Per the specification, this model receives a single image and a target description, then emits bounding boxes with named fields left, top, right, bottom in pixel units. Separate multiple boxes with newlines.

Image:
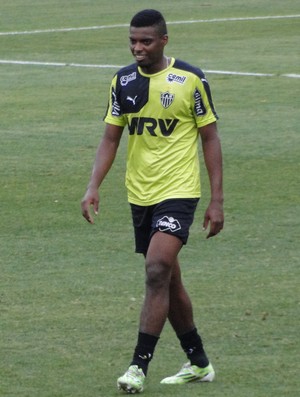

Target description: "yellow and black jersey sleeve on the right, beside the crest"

left=192, top=76, right=218, bottom=128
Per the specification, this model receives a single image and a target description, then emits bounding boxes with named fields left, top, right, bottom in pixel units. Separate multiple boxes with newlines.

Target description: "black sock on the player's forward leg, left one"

left=130, top=332, right=159, bottom=375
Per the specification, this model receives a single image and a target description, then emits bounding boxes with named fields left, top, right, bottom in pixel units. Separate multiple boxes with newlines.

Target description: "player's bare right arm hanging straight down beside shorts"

left=199, top=123, right=224, bottom=238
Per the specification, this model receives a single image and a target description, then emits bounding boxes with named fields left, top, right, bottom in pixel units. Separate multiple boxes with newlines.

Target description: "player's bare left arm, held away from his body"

left=81, top=124, right=123, bottom=223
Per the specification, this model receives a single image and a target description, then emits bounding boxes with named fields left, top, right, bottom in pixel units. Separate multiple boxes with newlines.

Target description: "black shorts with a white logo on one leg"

left=130, top=198, right=199, bottom=254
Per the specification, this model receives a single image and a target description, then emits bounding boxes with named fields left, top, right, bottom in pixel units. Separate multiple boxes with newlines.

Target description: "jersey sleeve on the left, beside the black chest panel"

left=103, top=74, right=127, bottom=127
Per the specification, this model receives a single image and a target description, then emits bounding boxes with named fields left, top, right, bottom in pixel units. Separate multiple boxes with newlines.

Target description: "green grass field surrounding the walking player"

left=0, top=0, right=300, bottom=397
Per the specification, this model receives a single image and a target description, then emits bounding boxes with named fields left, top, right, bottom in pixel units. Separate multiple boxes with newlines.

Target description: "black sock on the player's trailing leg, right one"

left=178, top=328, right=209, bottom=368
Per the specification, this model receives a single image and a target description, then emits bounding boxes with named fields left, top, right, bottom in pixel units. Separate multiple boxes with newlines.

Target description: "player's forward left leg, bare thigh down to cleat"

left=117, top=232, right=182, bottom=393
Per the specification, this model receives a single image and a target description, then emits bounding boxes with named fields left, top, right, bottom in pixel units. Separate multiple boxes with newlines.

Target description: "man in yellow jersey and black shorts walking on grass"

left=82, top=10, right=224, bottom=393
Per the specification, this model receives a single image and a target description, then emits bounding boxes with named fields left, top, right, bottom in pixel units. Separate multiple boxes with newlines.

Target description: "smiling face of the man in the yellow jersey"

left=129, top=26, right=168, bottom=74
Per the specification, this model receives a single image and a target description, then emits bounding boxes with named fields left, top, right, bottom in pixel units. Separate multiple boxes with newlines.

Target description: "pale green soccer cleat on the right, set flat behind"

left=160, top=362, right=215, bottom=385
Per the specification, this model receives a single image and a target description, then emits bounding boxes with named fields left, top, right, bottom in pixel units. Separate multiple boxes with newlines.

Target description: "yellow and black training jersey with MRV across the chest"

left=104, top=59, right=217, bottom=206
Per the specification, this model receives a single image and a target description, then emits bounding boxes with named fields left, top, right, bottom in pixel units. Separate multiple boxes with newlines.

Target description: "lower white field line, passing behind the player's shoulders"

left=0, top=59, right=300, bottom=79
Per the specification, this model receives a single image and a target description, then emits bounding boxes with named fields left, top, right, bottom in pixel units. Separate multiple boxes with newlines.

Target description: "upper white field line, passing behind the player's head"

left=0, top=14, right=300, bottom=36
